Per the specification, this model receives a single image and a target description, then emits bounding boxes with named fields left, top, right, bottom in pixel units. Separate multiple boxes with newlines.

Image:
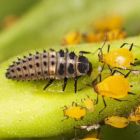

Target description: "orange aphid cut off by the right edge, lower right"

left=128, top=106, right=140, bottom=123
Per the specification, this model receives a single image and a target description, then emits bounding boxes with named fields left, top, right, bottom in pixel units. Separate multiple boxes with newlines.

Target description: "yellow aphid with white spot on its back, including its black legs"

left=98, top=43, right=135, bottom=70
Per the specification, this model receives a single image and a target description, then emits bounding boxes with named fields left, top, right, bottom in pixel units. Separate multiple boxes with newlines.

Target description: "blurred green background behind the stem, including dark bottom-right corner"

left=0, top=0, right=140, bottom=140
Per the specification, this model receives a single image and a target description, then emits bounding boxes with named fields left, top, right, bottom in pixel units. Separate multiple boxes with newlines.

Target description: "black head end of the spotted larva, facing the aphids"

left=77, top=56, right=92, bottom=75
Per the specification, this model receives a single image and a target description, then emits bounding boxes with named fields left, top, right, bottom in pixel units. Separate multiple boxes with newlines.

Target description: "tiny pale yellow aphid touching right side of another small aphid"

left=82, top=97, right=94, bottom=112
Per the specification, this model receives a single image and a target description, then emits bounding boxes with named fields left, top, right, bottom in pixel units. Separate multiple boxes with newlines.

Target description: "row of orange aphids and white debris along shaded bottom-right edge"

left=75, top=106, right=140, bottom=140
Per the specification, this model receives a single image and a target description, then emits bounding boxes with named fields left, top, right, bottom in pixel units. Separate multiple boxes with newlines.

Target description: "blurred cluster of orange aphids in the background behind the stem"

left=62, top=16, right=126, bottom=45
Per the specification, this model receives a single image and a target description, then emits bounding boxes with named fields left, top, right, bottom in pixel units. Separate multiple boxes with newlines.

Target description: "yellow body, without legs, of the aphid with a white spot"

left=100, top=48, right=134, bottom=69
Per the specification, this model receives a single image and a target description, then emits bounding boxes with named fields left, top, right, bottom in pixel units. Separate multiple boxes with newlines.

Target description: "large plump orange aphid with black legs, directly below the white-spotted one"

left=93, top=70, right=135, bottom=112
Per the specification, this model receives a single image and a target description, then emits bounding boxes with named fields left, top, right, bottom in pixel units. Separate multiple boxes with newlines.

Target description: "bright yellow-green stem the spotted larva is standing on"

left=0, top=37, right=140, bottom=139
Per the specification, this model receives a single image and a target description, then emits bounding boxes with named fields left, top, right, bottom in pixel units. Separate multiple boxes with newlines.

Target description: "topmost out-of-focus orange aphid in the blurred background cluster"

left=94, top=16, right=123, bottom=31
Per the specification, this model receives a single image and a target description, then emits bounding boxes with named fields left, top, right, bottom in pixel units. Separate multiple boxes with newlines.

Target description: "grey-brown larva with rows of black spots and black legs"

left=6, top=49, right=92, bottom=92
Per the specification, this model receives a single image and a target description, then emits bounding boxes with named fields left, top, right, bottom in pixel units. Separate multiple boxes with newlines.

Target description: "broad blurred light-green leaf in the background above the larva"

left=0, top=0, right=140, bottom=61
